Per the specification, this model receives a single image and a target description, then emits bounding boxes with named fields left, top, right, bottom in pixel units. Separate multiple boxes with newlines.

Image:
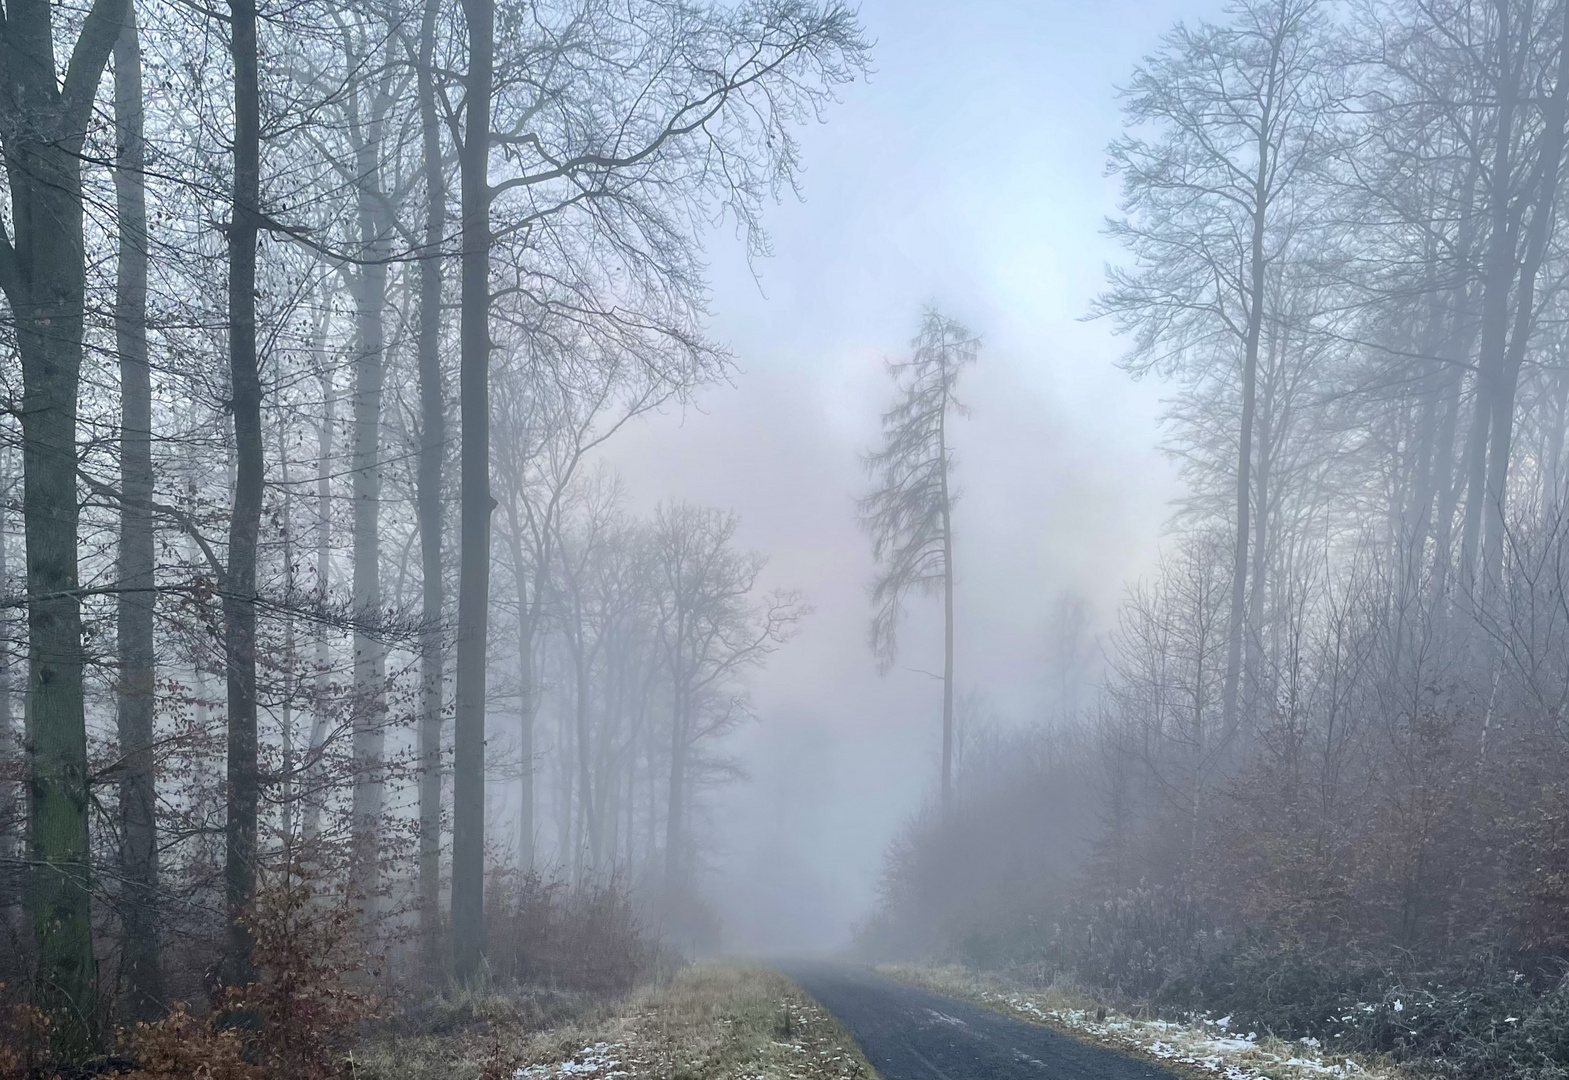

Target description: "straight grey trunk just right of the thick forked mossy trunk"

left=115, top=3, right=163, bottom=1020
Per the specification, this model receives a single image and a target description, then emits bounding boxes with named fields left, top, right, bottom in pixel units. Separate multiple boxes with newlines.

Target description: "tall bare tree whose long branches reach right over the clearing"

left=453, top=0, right=866, bottom=978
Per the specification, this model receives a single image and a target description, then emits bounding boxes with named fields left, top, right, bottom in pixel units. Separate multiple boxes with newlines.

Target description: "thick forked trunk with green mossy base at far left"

left=0, top=0, right=126, bottom=1060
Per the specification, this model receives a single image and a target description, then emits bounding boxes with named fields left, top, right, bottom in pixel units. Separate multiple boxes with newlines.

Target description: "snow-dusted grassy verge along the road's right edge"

left=877, top=964, right=1412, bottom=1080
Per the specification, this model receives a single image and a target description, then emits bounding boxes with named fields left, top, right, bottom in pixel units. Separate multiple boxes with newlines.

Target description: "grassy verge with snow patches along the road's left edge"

left=355, top=962, right=877, bottom=1080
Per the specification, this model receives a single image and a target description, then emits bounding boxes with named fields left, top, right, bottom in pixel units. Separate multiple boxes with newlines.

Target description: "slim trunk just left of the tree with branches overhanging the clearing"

left=416, top=0, right=447, bottom=975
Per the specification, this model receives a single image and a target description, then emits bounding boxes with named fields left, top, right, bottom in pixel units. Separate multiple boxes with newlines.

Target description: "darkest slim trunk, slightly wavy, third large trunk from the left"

left=223, top=0, right=262, bottom=986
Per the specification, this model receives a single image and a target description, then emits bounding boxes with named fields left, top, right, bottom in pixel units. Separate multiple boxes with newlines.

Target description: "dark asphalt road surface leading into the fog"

left=781, top=964, right=1178, bottom=1080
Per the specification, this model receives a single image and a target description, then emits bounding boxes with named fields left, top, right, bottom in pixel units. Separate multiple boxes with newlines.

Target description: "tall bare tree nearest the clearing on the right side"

left=1098, top=0, right=1331, bottom=756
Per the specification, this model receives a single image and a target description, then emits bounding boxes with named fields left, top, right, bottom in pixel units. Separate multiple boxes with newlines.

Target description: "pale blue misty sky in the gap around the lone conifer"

left=609, top=0, right=1219, bottom=950
